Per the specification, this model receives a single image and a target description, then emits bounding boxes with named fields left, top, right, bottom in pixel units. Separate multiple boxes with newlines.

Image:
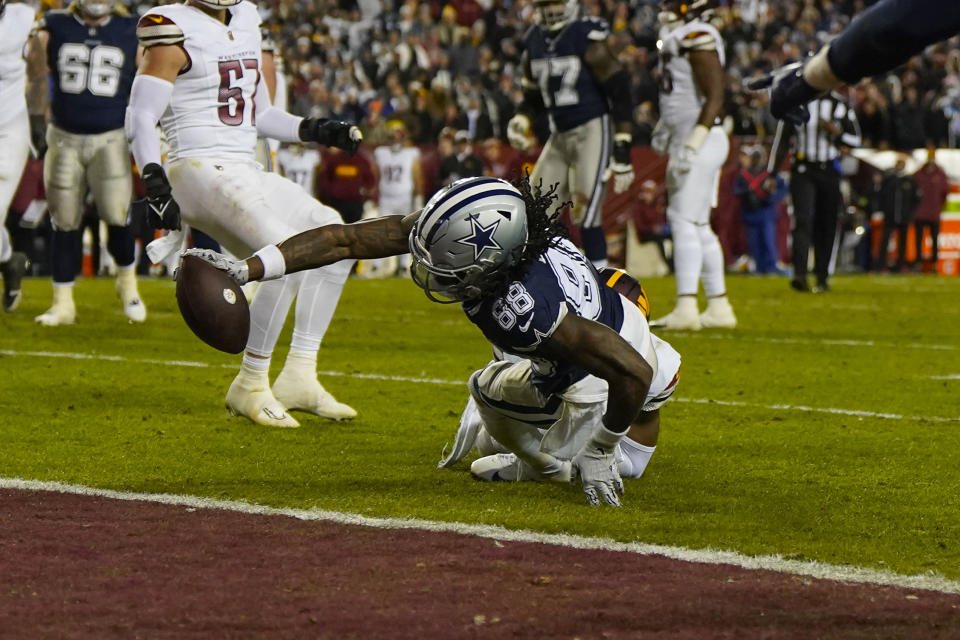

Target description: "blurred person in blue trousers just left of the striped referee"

left=733, top=146, right=787, bottom=275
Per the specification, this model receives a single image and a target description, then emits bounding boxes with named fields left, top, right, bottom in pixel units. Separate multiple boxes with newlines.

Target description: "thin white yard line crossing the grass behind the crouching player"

left=0, top=349, right=960, bottom=422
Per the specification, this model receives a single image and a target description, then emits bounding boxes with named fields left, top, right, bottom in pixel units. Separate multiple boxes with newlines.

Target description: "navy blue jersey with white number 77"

left=524, top=18, right=610, bottom=131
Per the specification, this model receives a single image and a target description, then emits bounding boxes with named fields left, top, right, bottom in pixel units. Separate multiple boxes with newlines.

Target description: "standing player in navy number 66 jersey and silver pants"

left=29, top=0, right=147, bottom=326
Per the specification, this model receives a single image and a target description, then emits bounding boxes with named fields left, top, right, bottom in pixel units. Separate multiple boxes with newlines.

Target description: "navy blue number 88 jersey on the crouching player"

left=464, top=240, right=623, bottom=395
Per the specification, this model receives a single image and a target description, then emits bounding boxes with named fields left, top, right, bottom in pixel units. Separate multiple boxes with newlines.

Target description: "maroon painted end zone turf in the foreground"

left=0, top=490, right=960, bottom=640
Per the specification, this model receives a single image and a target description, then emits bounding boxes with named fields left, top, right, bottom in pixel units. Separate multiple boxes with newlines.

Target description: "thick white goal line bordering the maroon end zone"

left=0, top=478, right=960, bottom=594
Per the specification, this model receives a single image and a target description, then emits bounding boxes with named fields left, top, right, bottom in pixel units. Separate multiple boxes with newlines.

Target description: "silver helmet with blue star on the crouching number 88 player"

left=410, top=177, right=527, bottom=303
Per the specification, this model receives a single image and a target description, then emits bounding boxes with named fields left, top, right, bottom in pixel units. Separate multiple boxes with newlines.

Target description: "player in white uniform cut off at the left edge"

left=0, top=0, right=34, bottom=311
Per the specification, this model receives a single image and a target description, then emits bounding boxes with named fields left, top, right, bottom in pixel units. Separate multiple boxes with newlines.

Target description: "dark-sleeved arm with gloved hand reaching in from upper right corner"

left=747, top=0, right=960, bottom=124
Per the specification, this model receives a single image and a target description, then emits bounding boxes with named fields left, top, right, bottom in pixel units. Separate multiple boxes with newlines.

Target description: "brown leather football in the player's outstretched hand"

left=177, top=256, right=250, bottom=353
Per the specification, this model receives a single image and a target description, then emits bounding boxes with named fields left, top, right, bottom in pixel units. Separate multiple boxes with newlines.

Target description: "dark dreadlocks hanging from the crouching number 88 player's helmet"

left=472, top=172, right=572, bottom=297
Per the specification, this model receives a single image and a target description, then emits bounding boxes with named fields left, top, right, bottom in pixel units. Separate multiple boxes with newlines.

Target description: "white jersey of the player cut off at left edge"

left=0, top=4, right=34, bottom=125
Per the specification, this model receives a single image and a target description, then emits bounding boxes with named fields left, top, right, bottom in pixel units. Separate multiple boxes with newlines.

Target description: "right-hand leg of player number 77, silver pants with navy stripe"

left=570, top=115, right=612, bottom=269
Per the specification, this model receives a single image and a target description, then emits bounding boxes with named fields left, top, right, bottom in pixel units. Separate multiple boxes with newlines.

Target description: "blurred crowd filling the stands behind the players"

left=11, top=0, right=960, bottom=276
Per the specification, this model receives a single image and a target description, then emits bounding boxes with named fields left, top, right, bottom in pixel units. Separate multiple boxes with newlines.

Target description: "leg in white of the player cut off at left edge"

left=0, top=112, right=30, bottom=311
